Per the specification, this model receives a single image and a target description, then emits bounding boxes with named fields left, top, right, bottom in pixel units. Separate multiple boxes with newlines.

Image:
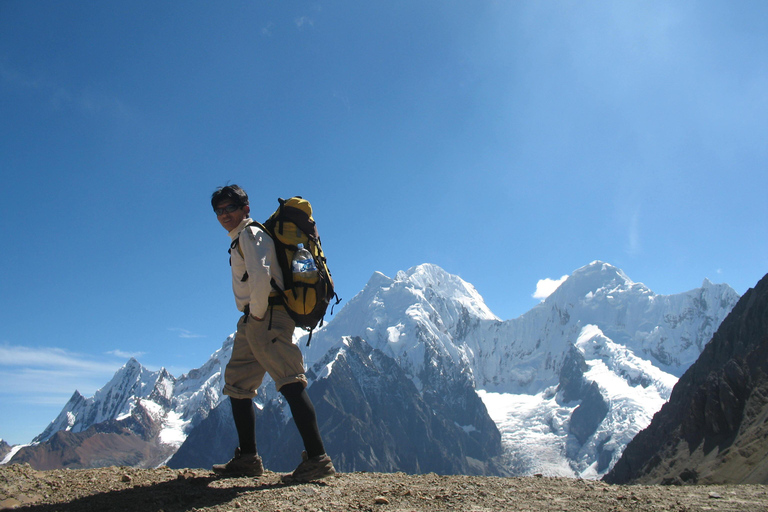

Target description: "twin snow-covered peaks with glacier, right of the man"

left=292, top=261, right=738, bottom=478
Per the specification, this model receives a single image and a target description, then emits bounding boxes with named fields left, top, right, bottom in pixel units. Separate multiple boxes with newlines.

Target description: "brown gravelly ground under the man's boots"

left=0, top=464, right=768, bottom=512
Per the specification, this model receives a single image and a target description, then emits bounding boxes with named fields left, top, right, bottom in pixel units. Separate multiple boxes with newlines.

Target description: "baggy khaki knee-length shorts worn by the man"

left=223, top=307, right=307, bottom=398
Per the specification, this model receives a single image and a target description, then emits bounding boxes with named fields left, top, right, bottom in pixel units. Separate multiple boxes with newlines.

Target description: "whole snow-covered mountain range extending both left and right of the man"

left=7, top=261, right=738, bottom=478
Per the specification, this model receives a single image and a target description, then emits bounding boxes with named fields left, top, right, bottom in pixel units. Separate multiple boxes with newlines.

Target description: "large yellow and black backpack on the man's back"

left=237, top=196, right=341, bottom=346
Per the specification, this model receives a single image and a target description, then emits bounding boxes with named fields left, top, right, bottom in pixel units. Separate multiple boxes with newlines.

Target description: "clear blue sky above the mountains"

left=0, top=0, right=768, bottom=443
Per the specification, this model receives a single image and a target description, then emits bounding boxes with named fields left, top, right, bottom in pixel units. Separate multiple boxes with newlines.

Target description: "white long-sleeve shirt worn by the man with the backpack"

left=229, top=218, right=283, bottom=318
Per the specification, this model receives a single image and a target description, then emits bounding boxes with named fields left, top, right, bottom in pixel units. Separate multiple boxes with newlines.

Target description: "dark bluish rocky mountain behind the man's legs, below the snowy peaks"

left=168, top=338, right=501, bottom=474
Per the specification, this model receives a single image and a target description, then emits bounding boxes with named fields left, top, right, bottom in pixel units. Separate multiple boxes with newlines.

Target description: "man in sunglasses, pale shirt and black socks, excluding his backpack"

left=211, top=185, right=336, bottom=482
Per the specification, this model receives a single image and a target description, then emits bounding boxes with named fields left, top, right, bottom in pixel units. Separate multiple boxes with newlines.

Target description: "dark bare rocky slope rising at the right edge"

left=604, top=275, right=768, bottom=484
